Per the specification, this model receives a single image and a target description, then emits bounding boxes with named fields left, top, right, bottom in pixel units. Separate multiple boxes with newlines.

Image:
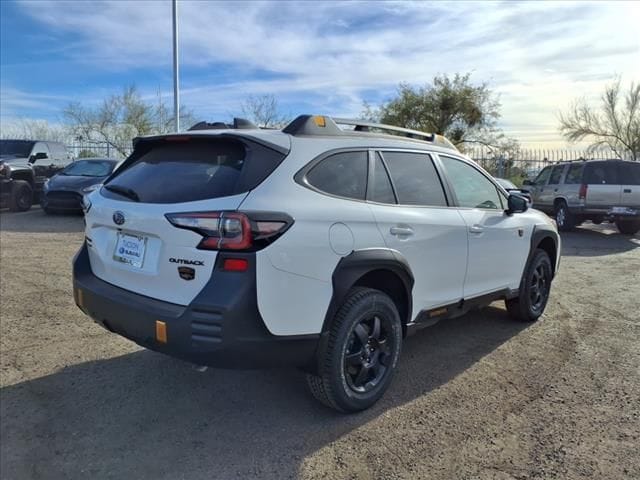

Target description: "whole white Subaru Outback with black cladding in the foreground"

left=73, top=115, right=560, bottom=412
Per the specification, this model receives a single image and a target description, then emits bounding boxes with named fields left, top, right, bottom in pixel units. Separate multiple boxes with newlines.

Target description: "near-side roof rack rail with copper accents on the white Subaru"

left=282, top=115, right=457, bottom=150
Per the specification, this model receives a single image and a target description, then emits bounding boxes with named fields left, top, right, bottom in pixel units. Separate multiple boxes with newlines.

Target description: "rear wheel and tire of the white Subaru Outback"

left=307, top=287, right=402, bottom=412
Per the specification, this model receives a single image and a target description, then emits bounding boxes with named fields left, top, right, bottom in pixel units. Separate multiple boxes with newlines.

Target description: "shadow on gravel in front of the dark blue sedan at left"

left=0, top=205, right=84, bottom=233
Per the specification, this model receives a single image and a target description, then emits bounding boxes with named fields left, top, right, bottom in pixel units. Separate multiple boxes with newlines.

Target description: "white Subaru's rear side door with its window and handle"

left=367, top=151, right=467, bottom=317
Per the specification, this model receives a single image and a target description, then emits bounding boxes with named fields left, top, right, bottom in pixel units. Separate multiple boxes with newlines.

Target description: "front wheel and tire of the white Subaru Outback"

left=505, top=248, right=553, bottom=322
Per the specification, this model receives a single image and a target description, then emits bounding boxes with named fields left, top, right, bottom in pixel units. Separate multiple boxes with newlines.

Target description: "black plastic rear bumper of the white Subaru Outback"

left=73, top=245, right=320, bottom=368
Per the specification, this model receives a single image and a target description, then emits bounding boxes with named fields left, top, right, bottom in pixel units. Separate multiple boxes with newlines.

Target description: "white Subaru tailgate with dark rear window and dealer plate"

left=86, top=137, right=284, bottom=305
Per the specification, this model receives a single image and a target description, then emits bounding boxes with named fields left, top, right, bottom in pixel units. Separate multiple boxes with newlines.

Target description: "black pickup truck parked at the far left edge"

left=0, top=140, right=72, bottom=212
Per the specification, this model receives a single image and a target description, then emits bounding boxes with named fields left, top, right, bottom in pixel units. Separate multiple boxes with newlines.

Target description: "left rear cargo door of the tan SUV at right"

left=583, top=160, right=622, bottom=210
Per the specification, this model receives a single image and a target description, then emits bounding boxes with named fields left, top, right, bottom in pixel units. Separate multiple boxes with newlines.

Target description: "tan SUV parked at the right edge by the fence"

left=525, top=160, right=640, bottom=235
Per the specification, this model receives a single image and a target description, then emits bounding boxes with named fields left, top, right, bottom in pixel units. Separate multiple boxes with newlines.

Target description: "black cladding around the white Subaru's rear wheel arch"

left=322, top=249, right=414, bottom=334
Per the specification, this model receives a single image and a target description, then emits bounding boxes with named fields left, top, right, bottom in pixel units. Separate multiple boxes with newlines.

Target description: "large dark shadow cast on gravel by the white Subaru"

left=0, top=306, right=526, bottom=479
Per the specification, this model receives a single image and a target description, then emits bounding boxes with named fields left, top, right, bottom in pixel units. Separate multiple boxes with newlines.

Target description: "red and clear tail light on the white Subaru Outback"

left=165, top=211, right=293, bottom=251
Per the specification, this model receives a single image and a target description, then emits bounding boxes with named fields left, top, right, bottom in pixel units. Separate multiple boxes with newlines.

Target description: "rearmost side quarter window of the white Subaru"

left=306, top=152, right=368, bottom=200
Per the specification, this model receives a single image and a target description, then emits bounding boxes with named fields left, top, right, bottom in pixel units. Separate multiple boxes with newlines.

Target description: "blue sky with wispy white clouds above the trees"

left=0, top=0, right=640, bottom=147
